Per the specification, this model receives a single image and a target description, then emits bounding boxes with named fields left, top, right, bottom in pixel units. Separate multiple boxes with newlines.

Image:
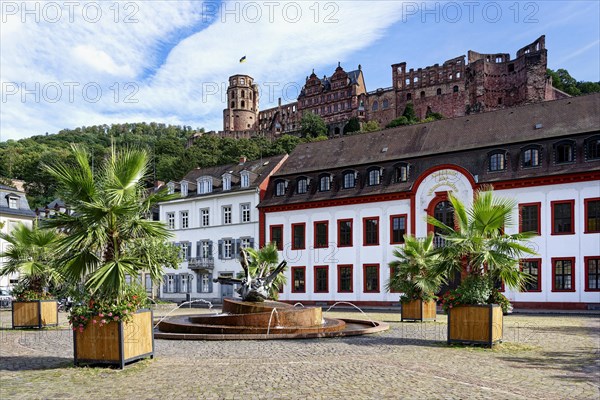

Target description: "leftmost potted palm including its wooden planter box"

left=0, top=224, right=60, bottom=328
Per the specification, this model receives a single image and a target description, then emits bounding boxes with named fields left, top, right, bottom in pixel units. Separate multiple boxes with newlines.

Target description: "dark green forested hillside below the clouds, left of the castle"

left=0, top=122, right=302, bottom=208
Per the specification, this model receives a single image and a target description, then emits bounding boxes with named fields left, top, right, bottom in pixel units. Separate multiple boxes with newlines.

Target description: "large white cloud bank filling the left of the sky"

left=0, top=1, right=410, bottom=140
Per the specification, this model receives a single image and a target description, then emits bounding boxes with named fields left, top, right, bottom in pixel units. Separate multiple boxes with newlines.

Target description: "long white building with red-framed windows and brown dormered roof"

left=260, top=95, right=600, bottom=309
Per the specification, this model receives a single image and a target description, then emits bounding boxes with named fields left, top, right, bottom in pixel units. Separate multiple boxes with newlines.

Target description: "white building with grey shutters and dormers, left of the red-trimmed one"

left=159, top=156, right=287, bottom=303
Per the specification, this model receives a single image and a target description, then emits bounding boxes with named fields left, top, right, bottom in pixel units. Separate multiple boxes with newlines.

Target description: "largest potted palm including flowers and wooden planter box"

left=46, top=146, right=179, bottom=368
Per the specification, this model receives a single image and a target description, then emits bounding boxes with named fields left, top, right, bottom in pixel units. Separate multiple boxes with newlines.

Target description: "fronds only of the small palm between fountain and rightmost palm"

left=387, top=235, right=443, bottom=301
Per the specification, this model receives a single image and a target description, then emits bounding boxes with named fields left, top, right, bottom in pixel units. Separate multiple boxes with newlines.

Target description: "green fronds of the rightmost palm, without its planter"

left=428, top=188, right=536, bottom=288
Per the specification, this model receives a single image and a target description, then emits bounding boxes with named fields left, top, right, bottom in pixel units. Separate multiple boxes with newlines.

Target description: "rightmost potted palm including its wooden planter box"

left=429, top=188, right=535, bottom=346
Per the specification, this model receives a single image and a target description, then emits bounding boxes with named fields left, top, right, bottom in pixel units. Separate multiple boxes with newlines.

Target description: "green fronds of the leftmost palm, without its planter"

left=0, top=224, right=61, bottom=295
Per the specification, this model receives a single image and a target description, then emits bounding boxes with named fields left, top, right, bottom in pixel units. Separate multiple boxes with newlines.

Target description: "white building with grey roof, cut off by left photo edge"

left=0, top=185, right=36, bottom=289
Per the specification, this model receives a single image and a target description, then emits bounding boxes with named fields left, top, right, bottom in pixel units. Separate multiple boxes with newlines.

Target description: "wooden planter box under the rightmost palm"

left=448, top=304, right=504, bottom=347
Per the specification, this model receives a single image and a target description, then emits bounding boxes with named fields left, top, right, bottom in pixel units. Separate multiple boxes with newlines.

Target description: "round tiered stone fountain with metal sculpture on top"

left=154, top=249, right=389, bottom=340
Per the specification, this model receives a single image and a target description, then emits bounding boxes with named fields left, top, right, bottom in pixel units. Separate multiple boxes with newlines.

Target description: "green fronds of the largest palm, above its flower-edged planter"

left=46, top=145, right=178, bottom=302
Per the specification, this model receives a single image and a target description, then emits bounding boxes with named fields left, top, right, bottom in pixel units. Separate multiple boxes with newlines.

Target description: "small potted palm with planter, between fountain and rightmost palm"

left=387, top=235, right=443, bottom=321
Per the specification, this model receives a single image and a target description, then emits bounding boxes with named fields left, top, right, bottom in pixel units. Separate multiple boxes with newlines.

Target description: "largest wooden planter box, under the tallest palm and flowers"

left=73, top=310, right=154, bottom=369
